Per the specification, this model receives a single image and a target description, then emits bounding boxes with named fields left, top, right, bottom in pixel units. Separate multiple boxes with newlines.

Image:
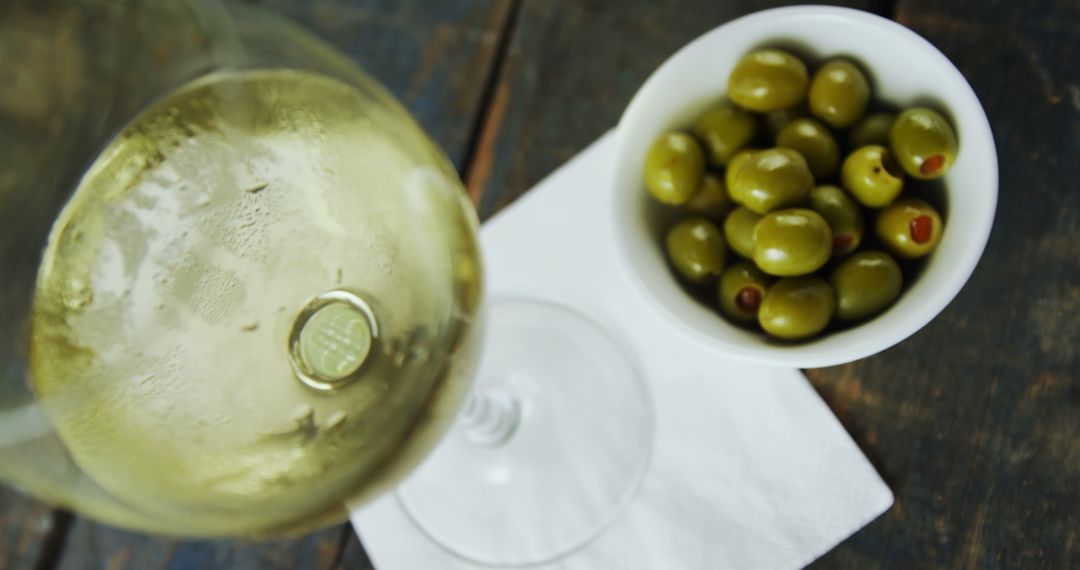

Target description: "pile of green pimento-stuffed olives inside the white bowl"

left=644, top=49, right=958, bottom=339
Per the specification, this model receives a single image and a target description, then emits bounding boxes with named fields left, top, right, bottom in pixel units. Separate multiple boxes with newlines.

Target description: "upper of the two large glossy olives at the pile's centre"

left=728, top=148, right=813, bottom=214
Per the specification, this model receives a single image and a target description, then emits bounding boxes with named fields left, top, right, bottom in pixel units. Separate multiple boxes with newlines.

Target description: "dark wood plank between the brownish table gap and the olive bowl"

left=467, top=0, right=877, bottom=218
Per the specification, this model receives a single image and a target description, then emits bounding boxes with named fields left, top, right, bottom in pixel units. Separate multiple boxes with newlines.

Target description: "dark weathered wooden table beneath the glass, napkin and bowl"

left=0, top=0, right=1080, bottom=570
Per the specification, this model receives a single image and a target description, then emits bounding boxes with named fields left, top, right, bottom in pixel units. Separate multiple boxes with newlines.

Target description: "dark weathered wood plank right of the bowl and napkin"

left=811, top=0, right=1080, bottom=569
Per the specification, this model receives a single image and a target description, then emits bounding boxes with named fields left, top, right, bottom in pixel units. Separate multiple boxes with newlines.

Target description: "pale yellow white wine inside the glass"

left=30, top=69, right=481, bottom=534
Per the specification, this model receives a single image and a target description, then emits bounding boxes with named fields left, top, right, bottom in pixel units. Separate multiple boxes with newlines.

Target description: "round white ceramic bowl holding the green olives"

left=613, top=6, right=998, bottom=368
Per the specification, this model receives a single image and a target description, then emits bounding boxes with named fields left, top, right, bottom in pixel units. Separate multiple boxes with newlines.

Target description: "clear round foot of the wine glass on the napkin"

left=396, top=300, right=653, bottom=567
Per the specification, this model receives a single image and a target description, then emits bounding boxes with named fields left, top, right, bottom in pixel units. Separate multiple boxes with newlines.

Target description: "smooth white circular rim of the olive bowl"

left=611, top=5, right=999, bottom=368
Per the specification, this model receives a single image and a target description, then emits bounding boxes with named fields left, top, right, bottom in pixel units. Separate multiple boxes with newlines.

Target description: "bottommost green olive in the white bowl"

left=757, top=275, right=836, bottom=340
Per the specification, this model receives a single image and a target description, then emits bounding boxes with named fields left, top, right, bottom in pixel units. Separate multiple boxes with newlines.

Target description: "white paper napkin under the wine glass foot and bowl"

left=352, top=135, right=893, bottom=570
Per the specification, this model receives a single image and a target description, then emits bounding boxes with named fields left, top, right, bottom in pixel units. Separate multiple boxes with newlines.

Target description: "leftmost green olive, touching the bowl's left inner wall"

left=645, top=133, right=705, bottom=206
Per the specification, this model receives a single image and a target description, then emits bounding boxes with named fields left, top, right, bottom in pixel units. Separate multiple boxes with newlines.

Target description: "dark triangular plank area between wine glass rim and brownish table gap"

left=262, top=0, right=513, bottom=169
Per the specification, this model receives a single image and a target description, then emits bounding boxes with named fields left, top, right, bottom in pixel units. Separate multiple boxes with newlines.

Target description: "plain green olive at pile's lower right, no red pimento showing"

left=828, top=250, right=904, bottom=321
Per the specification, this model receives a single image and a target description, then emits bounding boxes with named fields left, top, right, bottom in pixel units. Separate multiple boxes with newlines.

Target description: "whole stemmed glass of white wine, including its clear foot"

left=0, top=0, right=652, bottom=566
